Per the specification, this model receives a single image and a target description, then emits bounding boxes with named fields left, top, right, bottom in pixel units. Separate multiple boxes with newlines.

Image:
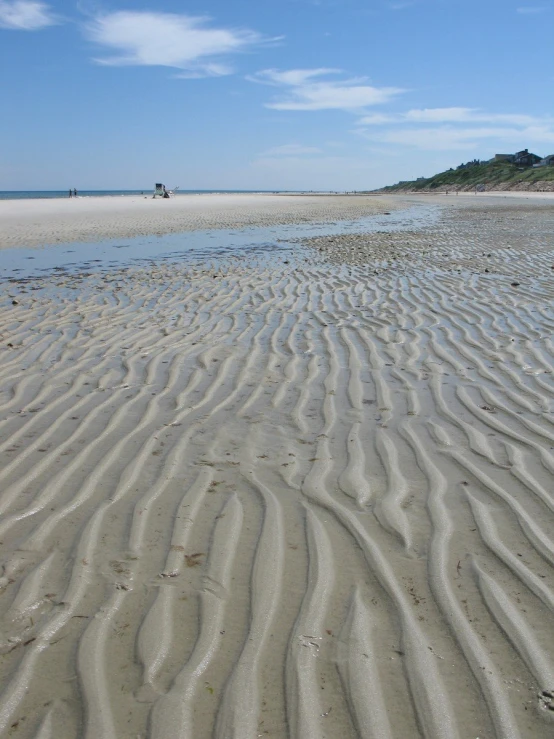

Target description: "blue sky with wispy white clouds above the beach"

left=0, top=0, right=554, bottom=190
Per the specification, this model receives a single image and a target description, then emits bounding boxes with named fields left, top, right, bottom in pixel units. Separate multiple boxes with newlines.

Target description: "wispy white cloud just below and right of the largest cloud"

left=249, top=68, right=404, bottom=111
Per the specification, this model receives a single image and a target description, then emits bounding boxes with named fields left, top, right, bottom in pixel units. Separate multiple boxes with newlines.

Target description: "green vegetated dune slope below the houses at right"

left=379, top=161, right=554, bottom=192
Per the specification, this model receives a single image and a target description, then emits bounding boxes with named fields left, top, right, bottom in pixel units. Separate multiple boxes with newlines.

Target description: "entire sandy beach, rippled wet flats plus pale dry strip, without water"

left=0, top=196, right=554, bottom=739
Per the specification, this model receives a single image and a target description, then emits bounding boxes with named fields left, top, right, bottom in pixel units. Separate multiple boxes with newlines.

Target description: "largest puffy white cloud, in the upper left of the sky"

left=86, top=11, right=276, bottom=77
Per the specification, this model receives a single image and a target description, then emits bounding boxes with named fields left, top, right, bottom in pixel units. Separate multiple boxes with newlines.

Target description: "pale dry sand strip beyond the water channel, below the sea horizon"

left=0, top=194, right=394, bottom=249
